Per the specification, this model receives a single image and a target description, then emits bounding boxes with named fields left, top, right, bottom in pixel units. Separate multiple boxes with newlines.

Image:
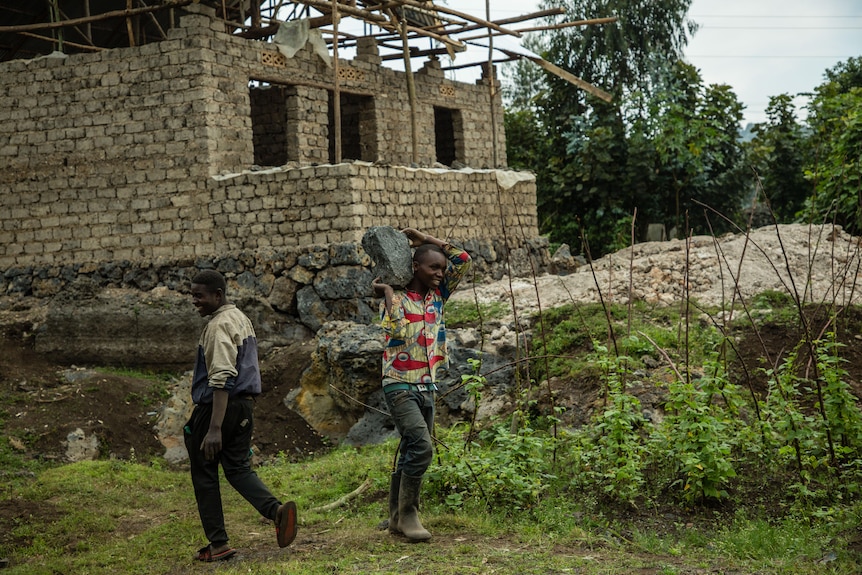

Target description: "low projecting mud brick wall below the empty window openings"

left=207, top=162, right=537, bottom=250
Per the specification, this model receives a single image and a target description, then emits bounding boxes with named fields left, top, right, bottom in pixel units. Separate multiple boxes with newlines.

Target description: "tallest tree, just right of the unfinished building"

left=507, top=0, right=694, bottom=253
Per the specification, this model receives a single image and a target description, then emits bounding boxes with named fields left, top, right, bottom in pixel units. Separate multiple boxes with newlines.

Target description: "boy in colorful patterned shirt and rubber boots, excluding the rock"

left=371, top=228, right=471, bottom=542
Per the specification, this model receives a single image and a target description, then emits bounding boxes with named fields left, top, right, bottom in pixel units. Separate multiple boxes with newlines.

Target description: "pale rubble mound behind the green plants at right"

left=453, top=224, right=862, bottom=314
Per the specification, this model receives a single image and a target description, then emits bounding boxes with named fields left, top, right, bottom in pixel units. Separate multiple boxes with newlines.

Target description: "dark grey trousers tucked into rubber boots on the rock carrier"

left=386, top=390, right=434, bottom=477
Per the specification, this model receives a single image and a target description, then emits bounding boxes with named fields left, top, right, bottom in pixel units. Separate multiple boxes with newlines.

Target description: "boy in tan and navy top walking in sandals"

left=185, top=270, right=297, bottom=562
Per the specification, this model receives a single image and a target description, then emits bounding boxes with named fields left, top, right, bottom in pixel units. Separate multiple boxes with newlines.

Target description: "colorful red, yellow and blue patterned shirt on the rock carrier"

left=380, top=245, right=472, bottom=383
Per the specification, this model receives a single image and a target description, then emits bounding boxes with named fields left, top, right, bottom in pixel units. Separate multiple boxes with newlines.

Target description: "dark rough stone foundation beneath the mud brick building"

left=20, top=235, right=549, bottom=364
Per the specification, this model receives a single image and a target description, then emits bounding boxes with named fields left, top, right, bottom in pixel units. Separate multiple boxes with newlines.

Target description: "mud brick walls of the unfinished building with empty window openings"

left=0, top=5, right=538, bottom=274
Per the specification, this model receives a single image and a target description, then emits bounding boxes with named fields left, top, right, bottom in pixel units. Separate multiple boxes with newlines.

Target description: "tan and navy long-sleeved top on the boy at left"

left=192, top=304, right=261, bottom=404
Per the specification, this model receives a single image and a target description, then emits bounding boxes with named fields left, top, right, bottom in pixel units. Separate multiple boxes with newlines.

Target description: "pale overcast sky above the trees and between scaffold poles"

left=446, top=0, right=862, bottom=126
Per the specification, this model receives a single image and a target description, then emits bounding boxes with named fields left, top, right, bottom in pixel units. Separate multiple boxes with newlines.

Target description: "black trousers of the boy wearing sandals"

left=185, top=398, right=281, bottom=546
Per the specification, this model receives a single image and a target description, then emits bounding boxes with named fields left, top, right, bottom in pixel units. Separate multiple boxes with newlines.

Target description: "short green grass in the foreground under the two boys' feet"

left=0, top=443, right=862, bottom=575
